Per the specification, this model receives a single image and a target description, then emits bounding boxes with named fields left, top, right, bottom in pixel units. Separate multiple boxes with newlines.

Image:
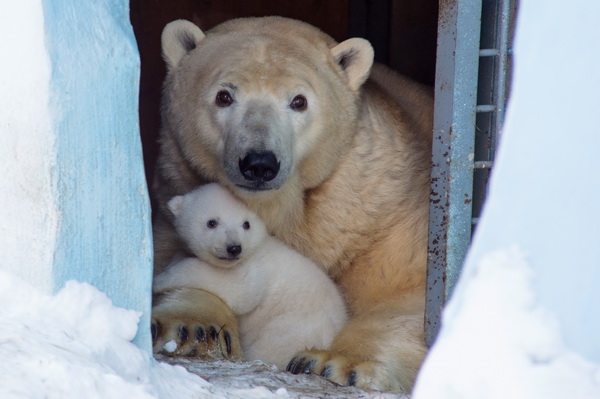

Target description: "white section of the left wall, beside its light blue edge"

left=0, top=0, right=59, bottom=292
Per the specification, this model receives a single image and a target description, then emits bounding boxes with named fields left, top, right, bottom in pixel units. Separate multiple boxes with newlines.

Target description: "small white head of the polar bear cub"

left=168, top=184, right=267, bottom=268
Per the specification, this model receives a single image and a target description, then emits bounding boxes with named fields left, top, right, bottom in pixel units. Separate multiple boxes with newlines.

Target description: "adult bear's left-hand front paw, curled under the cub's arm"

left=152, top=288, right=243, bottom=360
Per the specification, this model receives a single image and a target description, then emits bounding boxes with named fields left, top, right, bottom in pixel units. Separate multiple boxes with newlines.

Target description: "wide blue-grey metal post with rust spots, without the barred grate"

left=425, top=0, right=481, bottom=345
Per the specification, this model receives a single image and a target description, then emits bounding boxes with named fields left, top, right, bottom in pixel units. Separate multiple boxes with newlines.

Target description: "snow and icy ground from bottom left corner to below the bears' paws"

left=0, top=270, right=406, bottom=399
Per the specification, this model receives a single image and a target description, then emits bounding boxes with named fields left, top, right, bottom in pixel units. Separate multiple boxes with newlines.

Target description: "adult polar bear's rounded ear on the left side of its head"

left=160, top=19, right=205, bottom=70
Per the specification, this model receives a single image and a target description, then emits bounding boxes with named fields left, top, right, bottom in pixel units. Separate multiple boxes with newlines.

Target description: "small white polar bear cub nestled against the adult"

left=153, top=184, right=347, bottom=368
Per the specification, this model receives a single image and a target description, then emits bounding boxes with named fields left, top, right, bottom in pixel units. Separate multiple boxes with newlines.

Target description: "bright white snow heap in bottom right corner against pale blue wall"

left=413, top=247, right=600, bottom=399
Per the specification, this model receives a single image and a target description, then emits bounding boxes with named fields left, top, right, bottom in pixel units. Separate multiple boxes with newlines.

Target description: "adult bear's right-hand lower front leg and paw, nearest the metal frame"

left=287, top=301, right=427, bottom=393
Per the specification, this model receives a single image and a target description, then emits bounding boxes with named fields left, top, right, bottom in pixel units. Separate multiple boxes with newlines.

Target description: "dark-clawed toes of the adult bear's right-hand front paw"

left=287, top=350, right=390, bottom=391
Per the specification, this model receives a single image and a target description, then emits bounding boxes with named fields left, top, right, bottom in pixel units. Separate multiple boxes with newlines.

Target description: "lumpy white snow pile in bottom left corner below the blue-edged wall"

left=0, top=270, right=209, bottom=399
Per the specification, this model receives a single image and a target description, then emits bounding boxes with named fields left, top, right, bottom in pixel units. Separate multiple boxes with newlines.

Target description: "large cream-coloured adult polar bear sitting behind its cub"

left=153, top=17, right=432, bottom=392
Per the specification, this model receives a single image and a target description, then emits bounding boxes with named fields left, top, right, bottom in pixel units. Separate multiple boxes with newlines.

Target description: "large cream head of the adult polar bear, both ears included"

left=162, top=17, right=373, bottom=199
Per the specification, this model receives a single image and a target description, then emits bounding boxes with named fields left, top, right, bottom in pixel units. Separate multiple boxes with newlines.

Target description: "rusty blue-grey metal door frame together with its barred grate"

left=425, top=0, right=516, bottom=345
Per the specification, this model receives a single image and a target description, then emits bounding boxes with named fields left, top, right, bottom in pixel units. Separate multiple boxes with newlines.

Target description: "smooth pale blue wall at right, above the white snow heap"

left=466, top=0, right=600, bottom=362
